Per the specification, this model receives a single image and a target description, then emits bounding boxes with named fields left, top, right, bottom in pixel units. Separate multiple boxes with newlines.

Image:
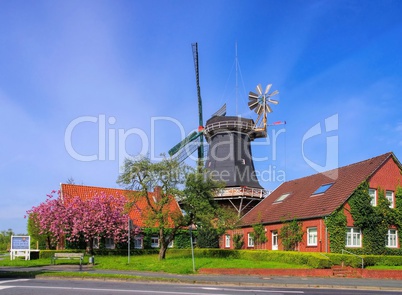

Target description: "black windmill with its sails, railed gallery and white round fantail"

left=169, top=43, right=279, bottom=216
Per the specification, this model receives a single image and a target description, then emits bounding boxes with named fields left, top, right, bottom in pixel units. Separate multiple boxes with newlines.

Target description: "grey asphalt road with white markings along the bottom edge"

left=0, top=279, right=402, bottom=295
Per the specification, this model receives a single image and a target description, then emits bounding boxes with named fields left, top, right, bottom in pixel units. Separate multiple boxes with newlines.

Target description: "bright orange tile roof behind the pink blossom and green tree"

left=60, top=183, right=181, bottom=228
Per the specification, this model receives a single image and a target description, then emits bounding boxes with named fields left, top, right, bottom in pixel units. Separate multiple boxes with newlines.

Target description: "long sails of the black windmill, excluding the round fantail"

left=168, top=43, right=226, bottom=167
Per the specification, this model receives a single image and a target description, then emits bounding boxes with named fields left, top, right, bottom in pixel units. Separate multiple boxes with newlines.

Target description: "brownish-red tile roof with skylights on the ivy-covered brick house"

left=242, top=152, right=400, bottom=226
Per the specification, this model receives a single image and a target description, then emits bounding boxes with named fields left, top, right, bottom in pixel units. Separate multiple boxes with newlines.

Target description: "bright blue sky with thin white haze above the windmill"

left=0, top=0, right=402, bottom=233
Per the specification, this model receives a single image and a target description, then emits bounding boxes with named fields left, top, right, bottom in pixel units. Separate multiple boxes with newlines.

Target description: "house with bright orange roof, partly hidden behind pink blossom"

left=60, top=183, right=182, bottom=249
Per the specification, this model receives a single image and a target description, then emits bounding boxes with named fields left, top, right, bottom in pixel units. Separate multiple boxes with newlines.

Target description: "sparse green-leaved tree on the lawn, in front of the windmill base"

left=117, top=157, right=219, bottom=260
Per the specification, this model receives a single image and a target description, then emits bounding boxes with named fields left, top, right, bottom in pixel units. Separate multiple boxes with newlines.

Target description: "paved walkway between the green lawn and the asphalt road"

left=0, top=265, right=402, bottom=292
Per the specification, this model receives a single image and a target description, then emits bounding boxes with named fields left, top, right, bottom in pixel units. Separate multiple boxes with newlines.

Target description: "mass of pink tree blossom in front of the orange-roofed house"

left=27, top=191, right=139, bottom=253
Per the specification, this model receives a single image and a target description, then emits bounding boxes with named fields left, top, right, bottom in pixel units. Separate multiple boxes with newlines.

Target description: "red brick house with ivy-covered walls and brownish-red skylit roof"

left=220, top=152, right=402, bottom=252
